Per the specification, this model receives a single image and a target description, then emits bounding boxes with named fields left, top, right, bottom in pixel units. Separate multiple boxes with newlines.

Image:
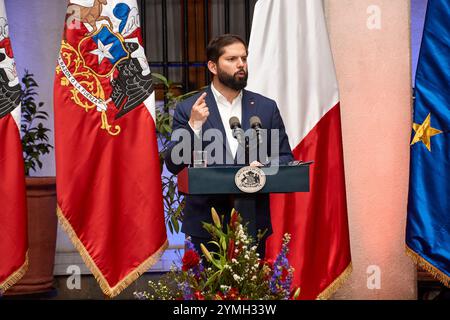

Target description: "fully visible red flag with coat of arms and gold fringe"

left=54, top=0, right=168, bottom=297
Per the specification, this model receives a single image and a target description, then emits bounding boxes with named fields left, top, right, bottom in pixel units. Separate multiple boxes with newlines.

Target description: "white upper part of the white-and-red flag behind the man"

left=248, top=0, right=339, bottom=148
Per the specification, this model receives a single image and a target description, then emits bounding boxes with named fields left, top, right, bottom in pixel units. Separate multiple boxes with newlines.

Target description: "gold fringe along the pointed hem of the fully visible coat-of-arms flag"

left=56, top=205, right=169, bottom=298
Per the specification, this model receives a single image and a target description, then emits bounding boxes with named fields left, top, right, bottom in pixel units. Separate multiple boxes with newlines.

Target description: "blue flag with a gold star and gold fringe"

left=406, top=0, right=450, bottom=287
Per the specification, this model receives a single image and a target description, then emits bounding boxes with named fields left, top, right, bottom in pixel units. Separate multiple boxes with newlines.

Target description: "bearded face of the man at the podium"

left=213, top=42, right=248, bottom=91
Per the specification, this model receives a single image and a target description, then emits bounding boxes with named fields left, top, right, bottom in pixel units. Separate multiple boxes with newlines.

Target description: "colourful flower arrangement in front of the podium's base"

left=135, top=209, right=300, bottom=300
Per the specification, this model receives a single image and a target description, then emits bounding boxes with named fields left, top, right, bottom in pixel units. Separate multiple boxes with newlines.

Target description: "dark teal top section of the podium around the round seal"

left=178, top=163, right=310, bottom=195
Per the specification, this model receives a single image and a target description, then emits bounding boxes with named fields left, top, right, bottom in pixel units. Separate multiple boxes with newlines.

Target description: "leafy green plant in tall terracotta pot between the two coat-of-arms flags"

left=8, top=70, right=57, bottom=295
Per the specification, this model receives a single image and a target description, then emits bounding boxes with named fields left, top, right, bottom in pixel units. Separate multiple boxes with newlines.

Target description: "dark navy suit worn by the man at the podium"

left=165, top=87, right=293, bottom=238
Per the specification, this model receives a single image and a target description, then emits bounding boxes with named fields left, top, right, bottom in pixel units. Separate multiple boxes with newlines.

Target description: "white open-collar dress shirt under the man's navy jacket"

left=189, top=83, right=242, bottom=157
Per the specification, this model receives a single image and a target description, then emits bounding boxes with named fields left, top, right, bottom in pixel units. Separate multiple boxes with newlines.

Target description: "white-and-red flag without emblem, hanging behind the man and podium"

left=248, top=0, right=351, bottom=299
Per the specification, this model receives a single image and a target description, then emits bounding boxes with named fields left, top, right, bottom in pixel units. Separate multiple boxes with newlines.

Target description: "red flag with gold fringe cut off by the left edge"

left=0, top=0, right=28, bottom=295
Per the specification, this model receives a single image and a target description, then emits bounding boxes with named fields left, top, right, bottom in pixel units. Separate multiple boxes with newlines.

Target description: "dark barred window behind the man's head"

left=139, top=0, right=256, bottom=92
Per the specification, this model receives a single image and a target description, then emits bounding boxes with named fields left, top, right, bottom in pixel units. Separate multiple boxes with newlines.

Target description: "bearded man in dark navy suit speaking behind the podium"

left=165, top=34, right=293, bottom=256
